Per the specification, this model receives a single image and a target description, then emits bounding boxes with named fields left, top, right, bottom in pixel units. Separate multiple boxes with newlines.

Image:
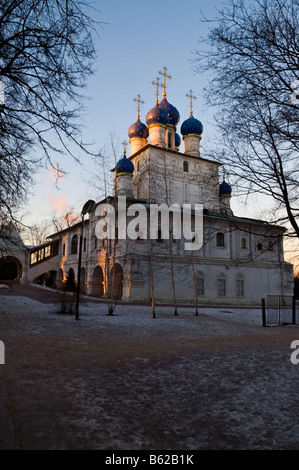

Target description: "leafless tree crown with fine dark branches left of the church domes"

left=0, top=0, right=101, bottom=217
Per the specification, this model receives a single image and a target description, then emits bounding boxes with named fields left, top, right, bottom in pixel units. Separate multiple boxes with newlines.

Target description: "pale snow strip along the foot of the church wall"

left=0, top=294, right=262, bottom=338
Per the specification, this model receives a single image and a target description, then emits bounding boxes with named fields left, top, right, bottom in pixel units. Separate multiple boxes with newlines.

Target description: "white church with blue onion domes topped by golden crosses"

left=2, top=69, right=294, bottom=305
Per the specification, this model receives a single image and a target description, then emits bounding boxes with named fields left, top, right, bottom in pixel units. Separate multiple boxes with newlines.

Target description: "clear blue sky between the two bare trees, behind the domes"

left=25, top=0, right=262, bottom=223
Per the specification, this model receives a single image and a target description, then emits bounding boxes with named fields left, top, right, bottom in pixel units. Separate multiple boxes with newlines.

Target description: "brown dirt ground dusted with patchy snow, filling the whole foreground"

left=0, top=296, right=299, bottom=450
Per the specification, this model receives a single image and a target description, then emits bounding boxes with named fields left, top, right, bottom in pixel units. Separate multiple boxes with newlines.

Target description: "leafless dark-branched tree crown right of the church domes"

left=195, top=0, right=299, bottom=241
